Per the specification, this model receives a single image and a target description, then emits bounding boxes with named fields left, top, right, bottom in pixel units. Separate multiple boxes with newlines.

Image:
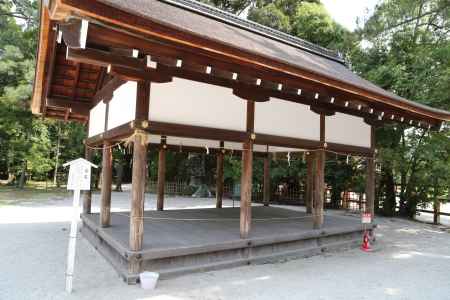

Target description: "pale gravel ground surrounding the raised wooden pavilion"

left=0, top=192, right=450, bottom=300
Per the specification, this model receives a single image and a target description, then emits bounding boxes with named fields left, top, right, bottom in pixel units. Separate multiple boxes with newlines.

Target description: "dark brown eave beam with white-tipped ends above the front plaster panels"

left=64, top=41, right=437, bottom=126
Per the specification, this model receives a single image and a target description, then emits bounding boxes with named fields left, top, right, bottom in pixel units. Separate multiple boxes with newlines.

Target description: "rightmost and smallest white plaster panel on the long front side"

left=325, top=113, right=371, bottom=148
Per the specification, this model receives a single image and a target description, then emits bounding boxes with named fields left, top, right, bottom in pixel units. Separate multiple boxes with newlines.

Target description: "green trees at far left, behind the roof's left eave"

left=0, top=0, right=84, bottom=185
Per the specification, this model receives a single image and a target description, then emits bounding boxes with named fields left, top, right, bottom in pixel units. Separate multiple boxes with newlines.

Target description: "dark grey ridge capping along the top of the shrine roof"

left=159, top=0, right=346, bottom=65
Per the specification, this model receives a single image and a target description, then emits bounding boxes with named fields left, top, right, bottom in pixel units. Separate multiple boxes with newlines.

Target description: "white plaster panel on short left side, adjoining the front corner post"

left=108, top=81, right=137, bottom=130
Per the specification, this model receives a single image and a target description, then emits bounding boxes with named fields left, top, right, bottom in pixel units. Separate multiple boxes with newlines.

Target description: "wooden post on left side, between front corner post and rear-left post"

left=100, top=142, right=112, bottom=227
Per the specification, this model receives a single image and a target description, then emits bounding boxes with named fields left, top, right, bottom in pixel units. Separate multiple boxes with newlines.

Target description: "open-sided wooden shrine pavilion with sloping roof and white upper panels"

left=32, top=0, right=450, bottom=282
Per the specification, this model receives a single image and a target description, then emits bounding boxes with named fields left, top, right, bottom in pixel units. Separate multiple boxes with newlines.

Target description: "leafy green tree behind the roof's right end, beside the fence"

left=352, top=0, right=450, bottom=217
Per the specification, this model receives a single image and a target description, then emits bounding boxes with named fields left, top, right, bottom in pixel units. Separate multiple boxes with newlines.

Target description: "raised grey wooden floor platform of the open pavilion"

left=82, top=206, right=372, bottom=283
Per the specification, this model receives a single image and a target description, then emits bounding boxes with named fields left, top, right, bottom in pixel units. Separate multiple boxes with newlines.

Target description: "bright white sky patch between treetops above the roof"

left=321, top=0, right=379, bottom=31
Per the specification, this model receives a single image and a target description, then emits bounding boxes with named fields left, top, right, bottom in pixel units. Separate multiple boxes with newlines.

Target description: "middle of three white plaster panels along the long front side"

left=255, top=98, right=320, bottom=141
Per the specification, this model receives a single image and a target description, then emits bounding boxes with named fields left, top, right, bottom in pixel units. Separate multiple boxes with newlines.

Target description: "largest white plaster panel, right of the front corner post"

left=149, top=78, right=246, bottom=131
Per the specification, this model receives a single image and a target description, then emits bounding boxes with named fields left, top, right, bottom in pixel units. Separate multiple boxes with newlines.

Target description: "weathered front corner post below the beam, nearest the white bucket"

left=130, top=130, right=147, bottom=251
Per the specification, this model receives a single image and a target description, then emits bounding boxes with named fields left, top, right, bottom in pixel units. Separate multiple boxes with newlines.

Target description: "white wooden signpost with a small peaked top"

left=63, top=158, right=97, bottom=293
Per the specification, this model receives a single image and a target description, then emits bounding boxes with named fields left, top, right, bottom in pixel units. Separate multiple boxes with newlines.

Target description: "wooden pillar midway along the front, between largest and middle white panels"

left=240, top=101, right=255, bottom=239
